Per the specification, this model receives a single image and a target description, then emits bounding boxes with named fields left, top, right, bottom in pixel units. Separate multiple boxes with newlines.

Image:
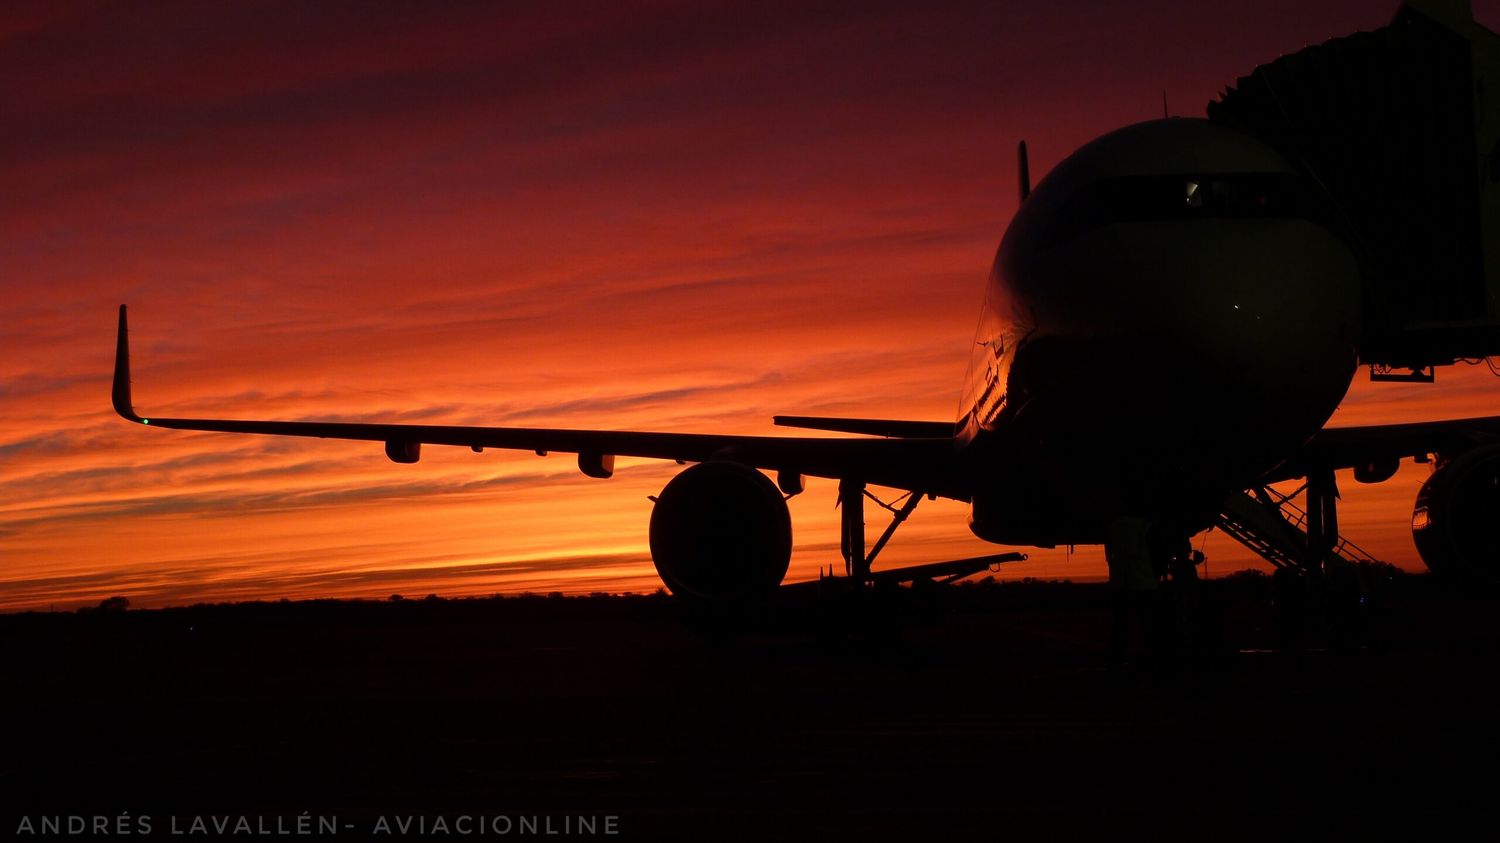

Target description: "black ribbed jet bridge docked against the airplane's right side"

left=1208, top=0, right=1500, bottom=373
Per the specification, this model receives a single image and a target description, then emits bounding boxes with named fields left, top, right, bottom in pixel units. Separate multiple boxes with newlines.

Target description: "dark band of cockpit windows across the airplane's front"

left=1044, top=173, right=1340, bottom=242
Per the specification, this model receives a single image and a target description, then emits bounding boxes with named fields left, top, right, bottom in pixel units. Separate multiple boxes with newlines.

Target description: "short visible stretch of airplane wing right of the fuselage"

left=1268, top=416, right=1500, bottom=483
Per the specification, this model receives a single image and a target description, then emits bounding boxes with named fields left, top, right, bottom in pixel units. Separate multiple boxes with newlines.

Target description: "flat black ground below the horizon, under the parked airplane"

left=0, top=576, right=1500, bottom=840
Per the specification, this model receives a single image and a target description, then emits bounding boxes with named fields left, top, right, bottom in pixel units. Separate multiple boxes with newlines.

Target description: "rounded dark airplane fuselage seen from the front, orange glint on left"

left=959, top=119, right=1361, bottom=546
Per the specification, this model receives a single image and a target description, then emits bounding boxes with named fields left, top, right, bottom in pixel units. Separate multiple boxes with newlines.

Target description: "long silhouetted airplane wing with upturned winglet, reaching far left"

left=113, top=305, right=966, bottom=498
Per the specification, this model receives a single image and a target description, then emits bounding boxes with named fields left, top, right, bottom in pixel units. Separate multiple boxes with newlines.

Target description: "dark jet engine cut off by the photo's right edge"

left=1412, top=446, right=1500, bottom=585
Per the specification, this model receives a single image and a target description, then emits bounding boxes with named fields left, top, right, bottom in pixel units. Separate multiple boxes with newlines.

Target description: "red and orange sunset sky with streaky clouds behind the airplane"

left=0, top=0, right=1500, bottom=611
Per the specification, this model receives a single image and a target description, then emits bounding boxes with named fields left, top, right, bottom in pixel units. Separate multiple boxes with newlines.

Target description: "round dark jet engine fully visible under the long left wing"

left=651, top=462, right=792, bottom=600
